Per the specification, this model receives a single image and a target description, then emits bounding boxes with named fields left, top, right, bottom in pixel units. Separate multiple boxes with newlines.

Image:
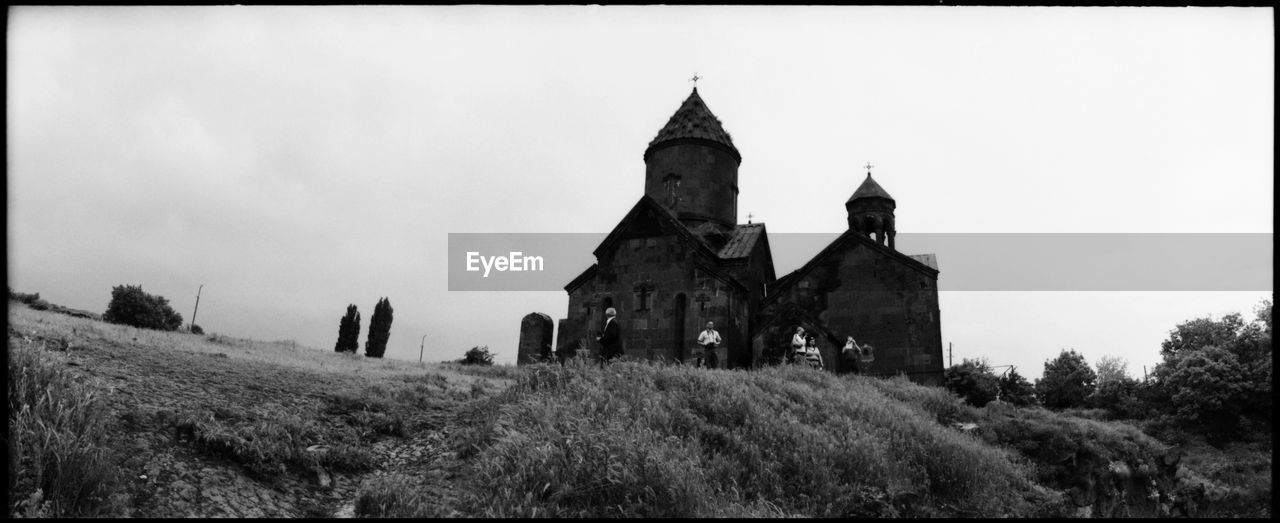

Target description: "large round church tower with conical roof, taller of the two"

left=644, top=87, right=742, bottom=228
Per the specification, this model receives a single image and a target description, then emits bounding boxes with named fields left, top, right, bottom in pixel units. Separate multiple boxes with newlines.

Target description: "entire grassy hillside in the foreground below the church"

left=9, top=302, right=1270, bottom=517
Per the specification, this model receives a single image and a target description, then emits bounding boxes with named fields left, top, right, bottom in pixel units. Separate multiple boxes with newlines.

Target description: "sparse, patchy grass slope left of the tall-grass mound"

left=8, top=302, right=499, bottom=517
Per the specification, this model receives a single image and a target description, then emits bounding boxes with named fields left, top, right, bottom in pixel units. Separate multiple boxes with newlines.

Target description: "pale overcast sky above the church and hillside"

left=6, top=6, right=1275, bottom=377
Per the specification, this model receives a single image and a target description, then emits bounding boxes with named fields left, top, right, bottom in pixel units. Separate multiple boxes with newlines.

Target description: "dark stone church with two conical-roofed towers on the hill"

left=518, top=87, right=942, bottom=384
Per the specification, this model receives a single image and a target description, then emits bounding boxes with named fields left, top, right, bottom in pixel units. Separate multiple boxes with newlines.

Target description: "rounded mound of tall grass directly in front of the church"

left=445, top=362, right=1038, bottom=517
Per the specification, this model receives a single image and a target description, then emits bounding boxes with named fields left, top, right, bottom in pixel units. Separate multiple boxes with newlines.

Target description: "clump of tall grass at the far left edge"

left=6, top=339, right=119, bottom=517
